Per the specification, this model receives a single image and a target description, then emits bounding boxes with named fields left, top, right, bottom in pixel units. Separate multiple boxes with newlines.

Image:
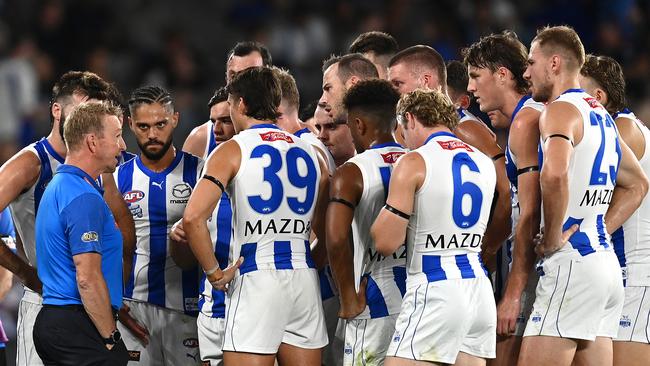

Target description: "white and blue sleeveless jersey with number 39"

left=227, top=124, right=321, bottom=274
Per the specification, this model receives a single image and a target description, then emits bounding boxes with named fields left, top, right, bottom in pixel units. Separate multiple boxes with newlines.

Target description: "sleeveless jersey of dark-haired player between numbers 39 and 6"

left=348, top=143, right=406, bottom=319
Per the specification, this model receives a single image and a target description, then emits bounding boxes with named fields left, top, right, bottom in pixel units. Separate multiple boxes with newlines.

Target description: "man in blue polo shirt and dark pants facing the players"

left=34, top=103, right=128, bottom=366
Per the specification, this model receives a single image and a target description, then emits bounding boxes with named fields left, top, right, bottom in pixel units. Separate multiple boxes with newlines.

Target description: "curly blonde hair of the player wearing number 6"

left=397, top=89, right=459, bottom=130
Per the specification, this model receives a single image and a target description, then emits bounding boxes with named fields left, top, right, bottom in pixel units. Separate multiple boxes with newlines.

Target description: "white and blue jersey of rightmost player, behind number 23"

left=612, top=108, right=650, bottom=286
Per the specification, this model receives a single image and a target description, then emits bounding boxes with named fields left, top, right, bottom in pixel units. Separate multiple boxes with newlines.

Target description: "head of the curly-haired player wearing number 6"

left=397, top=89, right=459, bottom=149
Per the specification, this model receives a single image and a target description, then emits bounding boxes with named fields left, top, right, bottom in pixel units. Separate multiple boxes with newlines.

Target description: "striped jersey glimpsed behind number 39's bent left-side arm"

left=199, top=134, right=232, bottom=318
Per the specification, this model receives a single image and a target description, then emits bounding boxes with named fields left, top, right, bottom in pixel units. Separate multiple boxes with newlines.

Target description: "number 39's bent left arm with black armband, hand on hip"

left=183, top=140, right=241, bottom=289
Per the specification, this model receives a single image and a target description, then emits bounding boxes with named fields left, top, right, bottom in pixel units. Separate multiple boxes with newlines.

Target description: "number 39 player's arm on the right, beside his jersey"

left=311, top=150, right=330, bottom=269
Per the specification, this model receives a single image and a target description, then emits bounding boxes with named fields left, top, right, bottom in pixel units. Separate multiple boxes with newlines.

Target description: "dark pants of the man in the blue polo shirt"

left=34, top=305, right=129, bottom=366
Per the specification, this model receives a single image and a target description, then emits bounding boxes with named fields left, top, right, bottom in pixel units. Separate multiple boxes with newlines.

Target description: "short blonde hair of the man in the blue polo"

left=63, top=101, right=122, bottom=151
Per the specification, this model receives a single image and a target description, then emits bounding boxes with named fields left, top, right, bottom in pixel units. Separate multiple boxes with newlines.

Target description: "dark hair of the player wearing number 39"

left=227, top=66, right=282, bottom=122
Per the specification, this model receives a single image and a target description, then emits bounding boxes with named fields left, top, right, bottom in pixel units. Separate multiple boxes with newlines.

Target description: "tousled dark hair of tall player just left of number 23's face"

left=463, top=31, right=528, bottom=94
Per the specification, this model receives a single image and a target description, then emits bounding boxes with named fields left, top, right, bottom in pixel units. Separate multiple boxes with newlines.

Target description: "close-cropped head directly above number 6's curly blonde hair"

left=388, top=45, right=447, bottom=94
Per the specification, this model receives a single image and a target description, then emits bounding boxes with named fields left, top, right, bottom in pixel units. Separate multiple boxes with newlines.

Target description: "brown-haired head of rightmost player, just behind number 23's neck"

left=580, top=55, right=627, bottom=114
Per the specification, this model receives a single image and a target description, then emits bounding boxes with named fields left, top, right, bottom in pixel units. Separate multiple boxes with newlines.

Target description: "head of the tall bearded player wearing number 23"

left=524, top=25, right=585, bottom=102
